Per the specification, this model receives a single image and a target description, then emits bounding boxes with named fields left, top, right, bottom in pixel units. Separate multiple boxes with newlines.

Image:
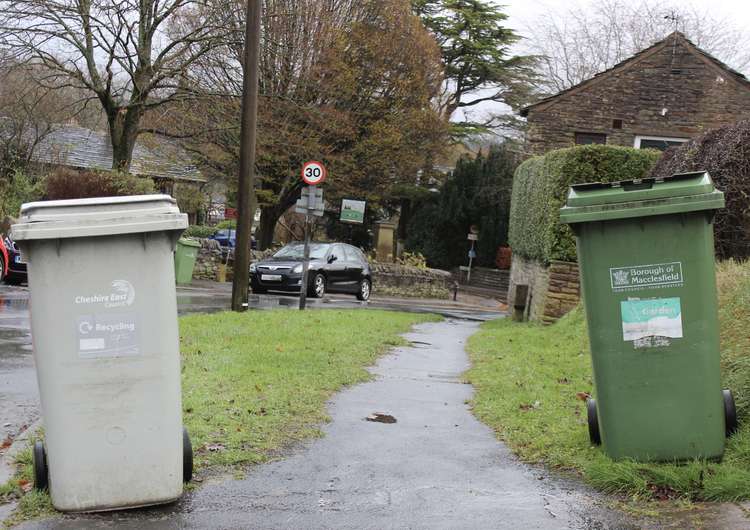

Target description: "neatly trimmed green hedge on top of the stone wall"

left=508, top=145, right=661, bottom=263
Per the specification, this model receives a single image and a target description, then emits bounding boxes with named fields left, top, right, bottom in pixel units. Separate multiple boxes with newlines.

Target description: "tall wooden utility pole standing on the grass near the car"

left=232, top=0, right=262, bottom=311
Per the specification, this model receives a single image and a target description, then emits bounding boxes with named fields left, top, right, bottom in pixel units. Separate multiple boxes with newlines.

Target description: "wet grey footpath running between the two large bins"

left=22, top=320, right=639, bottom=530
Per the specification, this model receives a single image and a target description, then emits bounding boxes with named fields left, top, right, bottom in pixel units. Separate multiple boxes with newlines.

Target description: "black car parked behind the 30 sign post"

left=250, top=242, right=372, bottom=300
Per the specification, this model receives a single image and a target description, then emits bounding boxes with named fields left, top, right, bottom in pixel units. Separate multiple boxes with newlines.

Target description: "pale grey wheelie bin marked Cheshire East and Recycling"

left=12, top=195, right=192, bottom=511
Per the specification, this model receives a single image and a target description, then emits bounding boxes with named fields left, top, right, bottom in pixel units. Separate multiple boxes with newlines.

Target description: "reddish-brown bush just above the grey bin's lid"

left=45, top=167, right=155, bottom=200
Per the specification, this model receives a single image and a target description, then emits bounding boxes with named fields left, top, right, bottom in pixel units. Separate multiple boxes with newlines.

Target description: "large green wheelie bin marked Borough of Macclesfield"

left=560, top=172, right=737, bottom=461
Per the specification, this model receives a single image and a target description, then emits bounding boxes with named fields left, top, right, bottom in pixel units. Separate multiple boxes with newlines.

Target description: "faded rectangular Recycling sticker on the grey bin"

left=77, top=313, right=141, bottom=359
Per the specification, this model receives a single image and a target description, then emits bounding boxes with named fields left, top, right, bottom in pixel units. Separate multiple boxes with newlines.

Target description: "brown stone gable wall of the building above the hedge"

left=521, top=32, right=750, bottom=155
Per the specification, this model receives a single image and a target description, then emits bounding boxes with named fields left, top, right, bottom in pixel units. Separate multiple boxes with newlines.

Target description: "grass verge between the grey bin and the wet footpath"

left=0, top=310, right=440, bottom=525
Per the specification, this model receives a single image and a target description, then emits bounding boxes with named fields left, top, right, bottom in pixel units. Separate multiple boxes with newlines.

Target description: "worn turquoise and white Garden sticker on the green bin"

left=620, top=298, right=682, bottom=345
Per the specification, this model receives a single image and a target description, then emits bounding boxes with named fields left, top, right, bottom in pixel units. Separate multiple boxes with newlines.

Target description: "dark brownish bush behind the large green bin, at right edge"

left=651, top=120, right=750, bottom=258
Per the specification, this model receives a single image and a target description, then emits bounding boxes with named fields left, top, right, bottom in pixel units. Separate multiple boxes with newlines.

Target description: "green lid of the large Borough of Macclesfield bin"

left=560, top=171, right=724, bottom=224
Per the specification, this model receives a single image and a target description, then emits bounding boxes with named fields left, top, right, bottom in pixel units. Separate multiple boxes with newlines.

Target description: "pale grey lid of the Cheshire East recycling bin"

left=12, top=195, right=188, bottom=241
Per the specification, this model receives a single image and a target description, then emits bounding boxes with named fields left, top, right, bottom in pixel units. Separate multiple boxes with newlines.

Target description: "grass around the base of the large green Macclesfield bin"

left=467, top=261, right=750, bottom=501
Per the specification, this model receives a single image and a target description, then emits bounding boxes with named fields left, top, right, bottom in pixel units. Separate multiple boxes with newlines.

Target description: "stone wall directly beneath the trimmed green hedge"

left=508, top=255, right=580, bottom=324
